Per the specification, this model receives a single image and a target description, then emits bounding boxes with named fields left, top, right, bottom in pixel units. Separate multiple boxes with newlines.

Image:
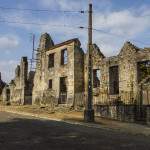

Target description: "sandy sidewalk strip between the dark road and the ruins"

left=0, top=106, right=150, bottom=136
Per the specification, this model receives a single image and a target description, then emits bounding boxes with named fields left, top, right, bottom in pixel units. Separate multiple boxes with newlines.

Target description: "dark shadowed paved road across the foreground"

left=0, top=112, right=150, bottom=150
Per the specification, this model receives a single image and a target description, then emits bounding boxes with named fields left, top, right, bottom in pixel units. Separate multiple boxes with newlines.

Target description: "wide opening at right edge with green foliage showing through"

left=137, top=60, right=150, bottom=82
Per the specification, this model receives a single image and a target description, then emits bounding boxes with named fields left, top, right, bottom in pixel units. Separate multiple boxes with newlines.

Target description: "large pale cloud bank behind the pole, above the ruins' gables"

left=37, top=5, right=150, bottom=56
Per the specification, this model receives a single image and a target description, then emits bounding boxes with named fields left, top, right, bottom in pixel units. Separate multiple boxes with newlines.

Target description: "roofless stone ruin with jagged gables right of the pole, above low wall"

left=93, top=42, right=150, bottom=105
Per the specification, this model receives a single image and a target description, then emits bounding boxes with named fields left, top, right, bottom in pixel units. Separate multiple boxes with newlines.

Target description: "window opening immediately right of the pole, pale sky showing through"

left=93, top=69, right=100, bottom=88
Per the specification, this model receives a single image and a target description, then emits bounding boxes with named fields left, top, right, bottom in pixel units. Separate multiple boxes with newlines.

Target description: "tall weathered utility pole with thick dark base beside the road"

left=84, top=3, right=94, bottom=122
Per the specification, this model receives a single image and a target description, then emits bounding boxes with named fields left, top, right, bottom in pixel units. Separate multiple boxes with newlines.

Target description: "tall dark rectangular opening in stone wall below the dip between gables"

left=109, top=66, right=119, bottom=95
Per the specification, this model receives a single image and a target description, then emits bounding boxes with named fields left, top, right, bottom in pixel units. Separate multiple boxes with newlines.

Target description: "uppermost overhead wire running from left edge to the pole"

left=0, top=6, right=87, bottom=13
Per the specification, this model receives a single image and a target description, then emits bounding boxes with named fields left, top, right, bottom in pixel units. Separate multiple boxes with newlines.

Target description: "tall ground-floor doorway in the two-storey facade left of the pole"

left=59, top=77, right=67, bottom=104
